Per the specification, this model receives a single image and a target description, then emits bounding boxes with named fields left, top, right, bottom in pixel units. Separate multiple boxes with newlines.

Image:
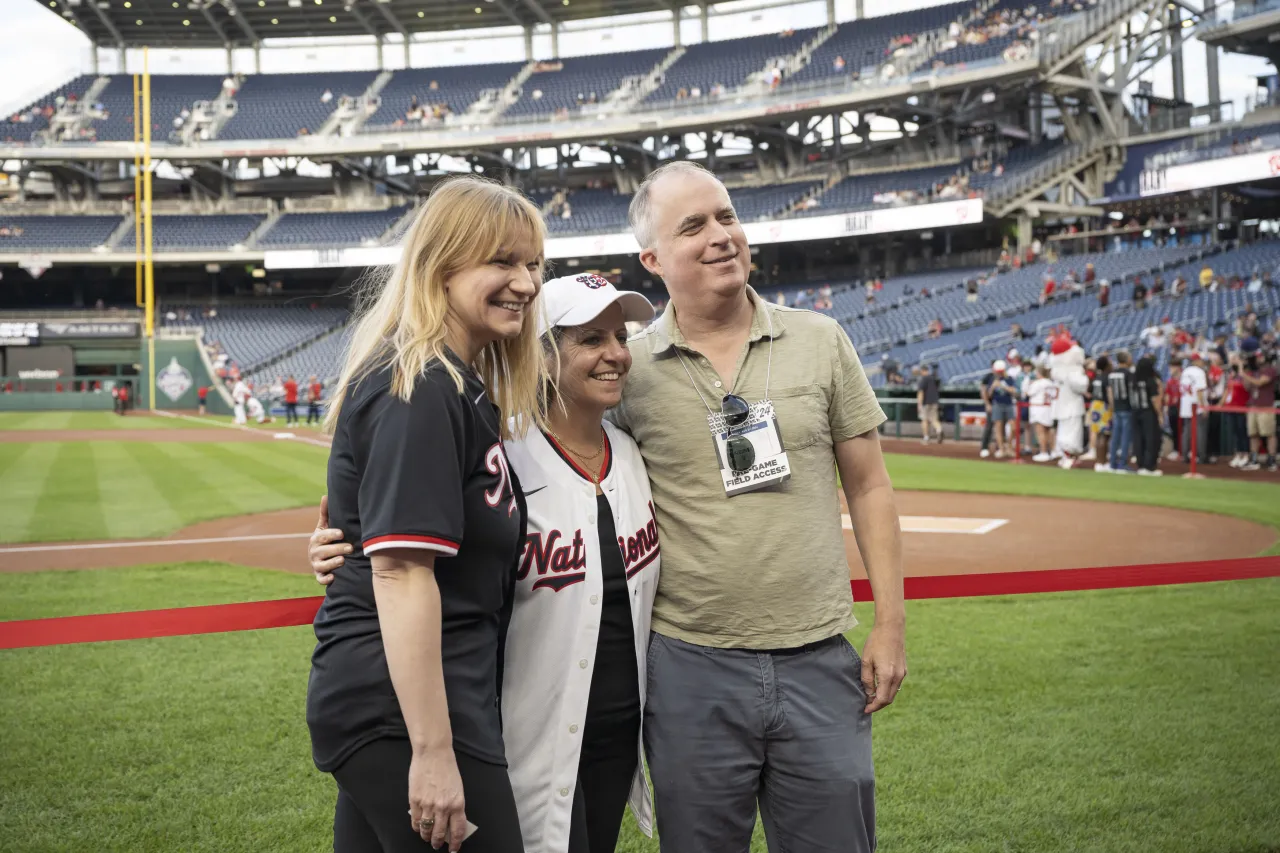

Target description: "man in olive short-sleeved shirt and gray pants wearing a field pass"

left=613, top=163, right=906, bottom=853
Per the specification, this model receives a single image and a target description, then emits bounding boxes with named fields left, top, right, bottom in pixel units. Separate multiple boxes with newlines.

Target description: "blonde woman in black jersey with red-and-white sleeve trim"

left=307, top=178, right=547, bottom=853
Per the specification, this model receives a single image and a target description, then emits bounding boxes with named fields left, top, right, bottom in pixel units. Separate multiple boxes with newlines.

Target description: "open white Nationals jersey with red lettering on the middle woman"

left=502, top=423, right=660, bottom=853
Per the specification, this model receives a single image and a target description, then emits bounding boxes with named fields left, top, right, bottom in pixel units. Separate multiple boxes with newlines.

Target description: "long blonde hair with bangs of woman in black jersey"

left=324, top=177, right=547, bottom=438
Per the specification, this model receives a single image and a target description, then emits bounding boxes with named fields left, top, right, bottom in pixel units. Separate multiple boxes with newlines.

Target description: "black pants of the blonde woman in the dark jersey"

left=333, top=738, right=525, bottom=853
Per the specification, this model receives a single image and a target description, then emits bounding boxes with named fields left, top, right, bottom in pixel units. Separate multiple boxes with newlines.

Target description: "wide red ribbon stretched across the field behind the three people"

left=0, top=557, right=1280, bottom=649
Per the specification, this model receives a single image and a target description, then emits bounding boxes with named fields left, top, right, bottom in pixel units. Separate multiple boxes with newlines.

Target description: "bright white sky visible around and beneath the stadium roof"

left=0, top=0, right=1274, bottom=123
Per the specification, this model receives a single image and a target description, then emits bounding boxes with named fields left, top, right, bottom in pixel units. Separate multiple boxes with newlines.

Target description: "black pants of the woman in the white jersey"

left=568, top=708, right=640, bottom=853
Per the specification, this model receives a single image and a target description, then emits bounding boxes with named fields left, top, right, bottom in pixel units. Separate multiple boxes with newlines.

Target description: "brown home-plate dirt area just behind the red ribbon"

left=0, top=491, right=1276, bottom=578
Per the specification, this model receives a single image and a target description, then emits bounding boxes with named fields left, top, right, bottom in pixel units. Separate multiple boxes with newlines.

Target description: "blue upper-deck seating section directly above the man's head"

left=645, top=29, right=818, bottom=102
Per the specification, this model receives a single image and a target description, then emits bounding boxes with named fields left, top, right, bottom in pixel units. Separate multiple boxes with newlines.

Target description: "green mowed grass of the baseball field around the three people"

left=0, top=414, right=1280, bottom=853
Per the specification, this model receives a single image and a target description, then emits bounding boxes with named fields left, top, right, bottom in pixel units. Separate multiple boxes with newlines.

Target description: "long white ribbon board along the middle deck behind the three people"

left=262, top=199, right=982, bottom=269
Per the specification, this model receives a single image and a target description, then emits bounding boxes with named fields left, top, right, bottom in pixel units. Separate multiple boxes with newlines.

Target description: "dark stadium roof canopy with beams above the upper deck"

left=35, top=0, right=680, bottom=47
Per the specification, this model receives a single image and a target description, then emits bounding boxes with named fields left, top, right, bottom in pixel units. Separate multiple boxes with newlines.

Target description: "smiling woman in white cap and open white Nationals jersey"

left=310, top=274, right=660, bottom=853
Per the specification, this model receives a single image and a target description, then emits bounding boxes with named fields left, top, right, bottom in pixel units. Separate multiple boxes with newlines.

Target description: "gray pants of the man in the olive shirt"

left=644, top=634, right=876, bottom=853
